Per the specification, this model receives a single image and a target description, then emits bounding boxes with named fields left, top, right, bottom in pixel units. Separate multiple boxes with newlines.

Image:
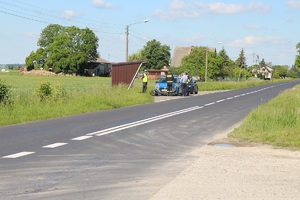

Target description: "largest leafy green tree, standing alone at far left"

left=26, top=24, right=99, bottom=74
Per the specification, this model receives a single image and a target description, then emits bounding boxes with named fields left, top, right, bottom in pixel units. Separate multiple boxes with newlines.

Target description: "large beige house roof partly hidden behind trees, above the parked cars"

left=170, top=46, right=216, bottom=67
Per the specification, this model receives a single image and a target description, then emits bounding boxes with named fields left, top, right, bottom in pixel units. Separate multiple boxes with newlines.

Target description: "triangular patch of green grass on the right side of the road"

left=229, top=85, right=300, bottom=149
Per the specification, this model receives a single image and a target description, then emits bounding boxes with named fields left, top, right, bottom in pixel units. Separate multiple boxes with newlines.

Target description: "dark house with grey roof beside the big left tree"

left=84, top=58, right=112, bottom=76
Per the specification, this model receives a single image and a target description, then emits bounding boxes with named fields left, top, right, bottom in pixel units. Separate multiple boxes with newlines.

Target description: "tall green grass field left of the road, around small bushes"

left=0, top=74, right=154, bottom=126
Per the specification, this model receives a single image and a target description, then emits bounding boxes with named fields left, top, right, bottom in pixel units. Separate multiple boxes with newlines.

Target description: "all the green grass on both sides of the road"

left=0, top=71, right=300, bottom=149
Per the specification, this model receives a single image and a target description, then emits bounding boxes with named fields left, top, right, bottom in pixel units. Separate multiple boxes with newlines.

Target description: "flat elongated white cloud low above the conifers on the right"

left=231, top=36, right=283, bottom=47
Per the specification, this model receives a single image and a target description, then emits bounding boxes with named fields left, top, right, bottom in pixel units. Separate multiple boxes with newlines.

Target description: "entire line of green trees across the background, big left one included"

left=26, top=24, right=300, bottom=80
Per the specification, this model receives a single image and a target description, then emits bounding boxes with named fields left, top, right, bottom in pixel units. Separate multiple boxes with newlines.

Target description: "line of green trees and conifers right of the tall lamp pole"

left=129, top=40, right=300, bottom=80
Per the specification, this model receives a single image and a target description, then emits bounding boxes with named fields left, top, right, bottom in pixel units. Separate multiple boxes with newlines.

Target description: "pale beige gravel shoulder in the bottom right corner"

left=150, top=93, right=300, bottom=200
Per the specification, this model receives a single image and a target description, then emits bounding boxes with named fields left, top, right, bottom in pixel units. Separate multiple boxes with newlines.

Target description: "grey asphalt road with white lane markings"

left=0, top=81, right=299, bottom=200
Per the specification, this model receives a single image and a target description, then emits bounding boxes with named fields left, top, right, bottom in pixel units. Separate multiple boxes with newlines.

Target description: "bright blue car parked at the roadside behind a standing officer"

left=154, top=76, right=182, bottom=96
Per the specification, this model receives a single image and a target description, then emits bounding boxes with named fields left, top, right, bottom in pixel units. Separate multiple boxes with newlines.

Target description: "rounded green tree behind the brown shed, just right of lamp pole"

left=129, top=40, right=171, bottom=69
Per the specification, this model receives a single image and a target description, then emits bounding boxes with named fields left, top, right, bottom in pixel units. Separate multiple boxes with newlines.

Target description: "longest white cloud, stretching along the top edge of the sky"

left=153, top=0, right=270, bottom=20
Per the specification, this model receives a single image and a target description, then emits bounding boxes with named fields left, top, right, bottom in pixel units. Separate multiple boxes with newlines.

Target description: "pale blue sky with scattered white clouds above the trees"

left=0, top=0, right=300, bottom=66
